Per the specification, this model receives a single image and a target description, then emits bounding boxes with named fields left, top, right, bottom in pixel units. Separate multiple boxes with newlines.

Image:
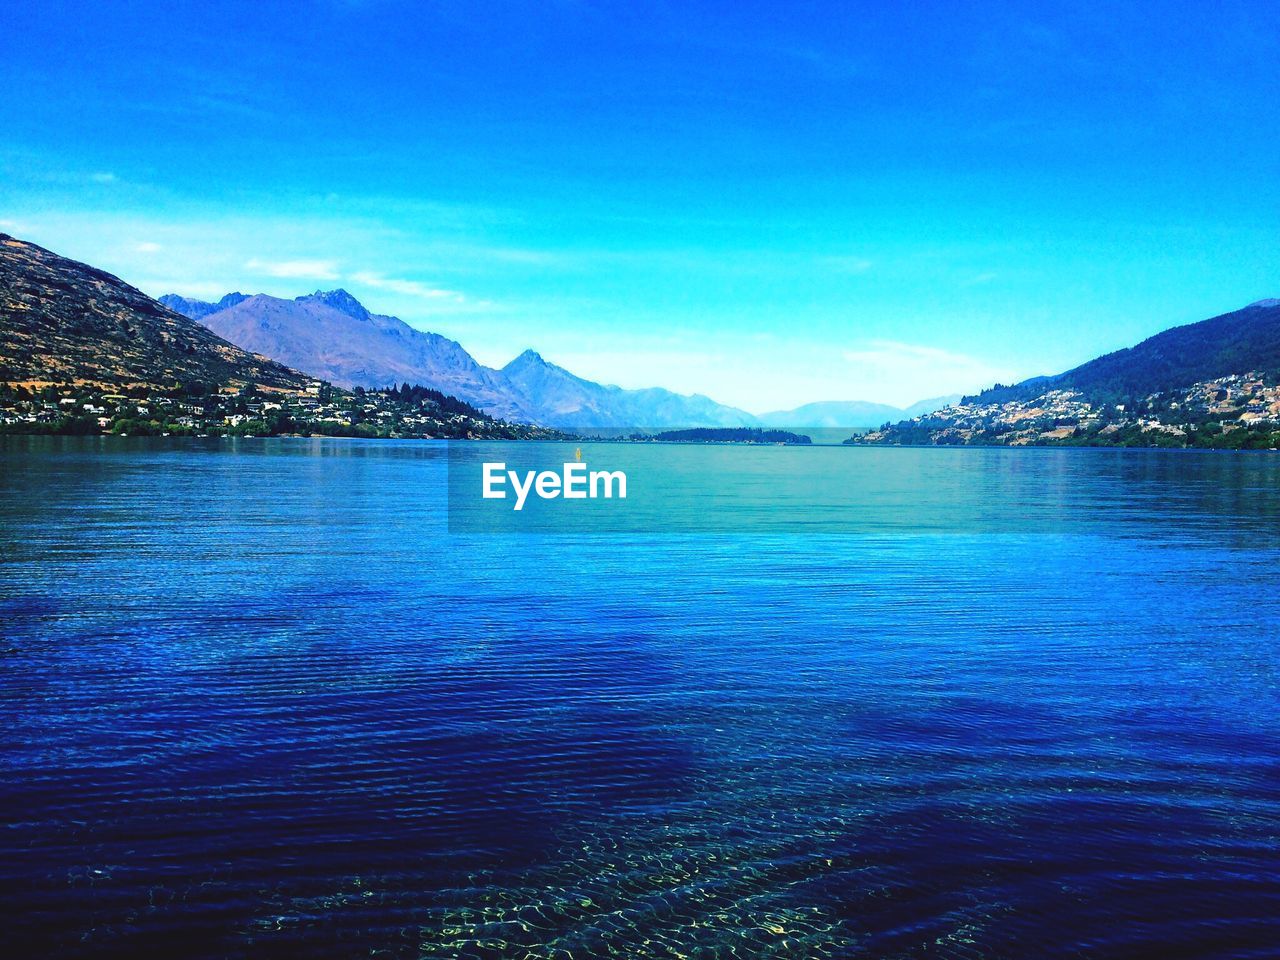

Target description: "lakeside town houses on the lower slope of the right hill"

left=846, top=372, right=1280, bottom=449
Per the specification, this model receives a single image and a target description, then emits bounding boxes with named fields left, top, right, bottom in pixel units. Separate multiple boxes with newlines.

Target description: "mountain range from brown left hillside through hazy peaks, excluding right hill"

left=0, top=234, right=962, bottom=429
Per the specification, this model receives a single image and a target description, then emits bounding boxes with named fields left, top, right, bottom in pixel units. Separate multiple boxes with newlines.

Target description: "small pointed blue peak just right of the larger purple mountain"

left=502, top=349, right=756, bottom=428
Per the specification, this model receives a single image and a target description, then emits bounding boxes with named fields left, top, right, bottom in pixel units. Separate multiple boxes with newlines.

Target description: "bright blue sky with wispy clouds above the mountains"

left=0, top=0, right=1280, bottom=412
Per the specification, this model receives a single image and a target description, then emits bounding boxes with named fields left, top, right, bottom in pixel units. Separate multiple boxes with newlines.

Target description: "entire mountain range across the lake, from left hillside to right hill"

left=17, top=227, right=1259, bottom=443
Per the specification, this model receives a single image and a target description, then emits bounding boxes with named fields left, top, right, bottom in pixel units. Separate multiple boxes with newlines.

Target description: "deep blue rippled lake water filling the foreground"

left=0, top=439, right=1280, bottom=957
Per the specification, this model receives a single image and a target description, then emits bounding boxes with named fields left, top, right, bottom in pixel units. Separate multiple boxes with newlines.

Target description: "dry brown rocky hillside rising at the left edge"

left=0, top=233, right=311, bottom=390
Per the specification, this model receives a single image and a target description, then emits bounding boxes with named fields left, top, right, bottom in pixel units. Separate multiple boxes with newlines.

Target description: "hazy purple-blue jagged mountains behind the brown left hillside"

left=164, top=289, right=756, bottom=428
